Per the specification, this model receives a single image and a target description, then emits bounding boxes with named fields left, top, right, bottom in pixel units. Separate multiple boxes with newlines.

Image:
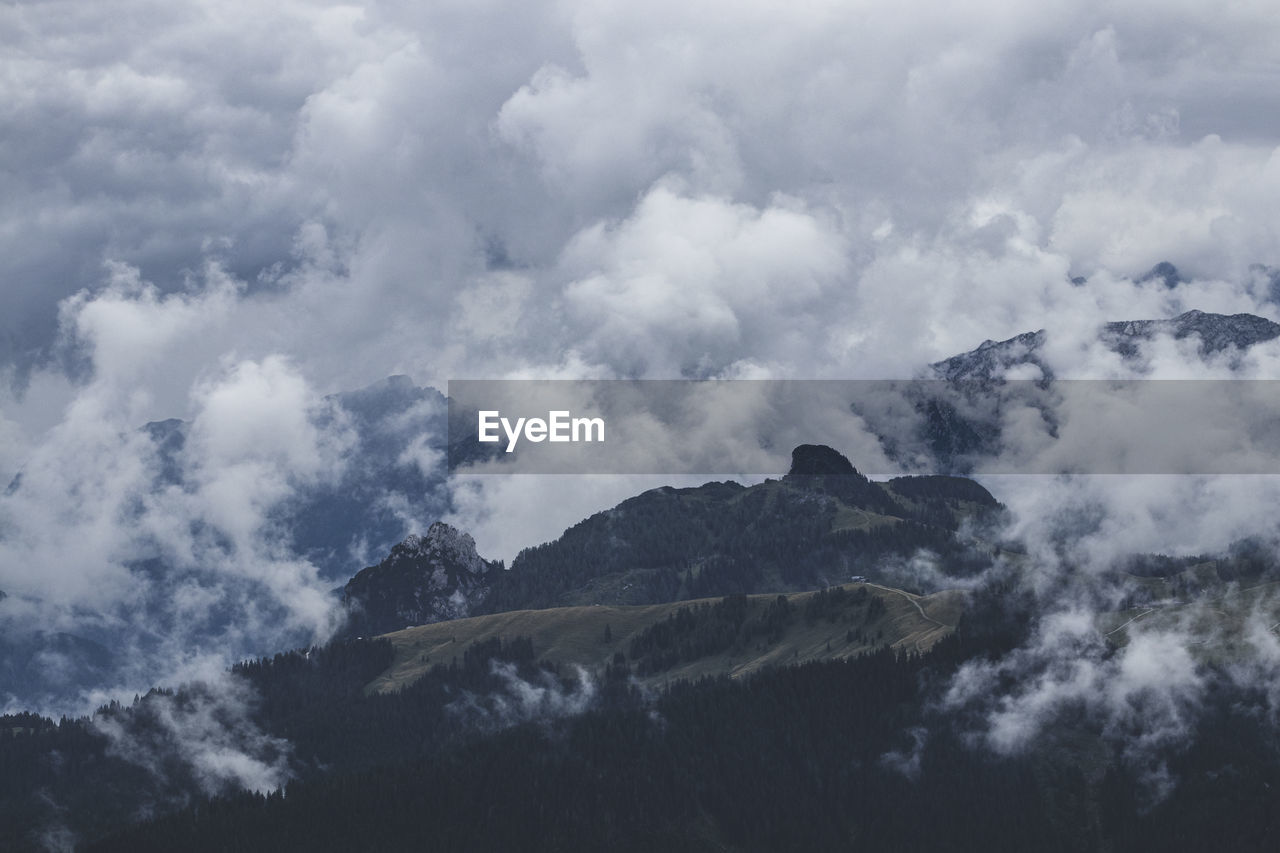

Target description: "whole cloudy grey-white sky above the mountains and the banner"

left=0, top=0, right=1280, bottom=701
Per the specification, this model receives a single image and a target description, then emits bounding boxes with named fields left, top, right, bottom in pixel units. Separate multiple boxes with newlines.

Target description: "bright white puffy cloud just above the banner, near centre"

left=562, top=186, right=846, bottom=377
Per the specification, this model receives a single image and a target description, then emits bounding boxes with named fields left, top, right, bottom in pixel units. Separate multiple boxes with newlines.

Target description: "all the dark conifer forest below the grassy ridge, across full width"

left=0, top=573, right=1280, bottom=850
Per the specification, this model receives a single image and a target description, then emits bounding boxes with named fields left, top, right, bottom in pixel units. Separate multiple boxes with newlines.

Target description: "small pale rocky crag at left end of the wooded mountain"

left=342, top=521, right=502, bottom=635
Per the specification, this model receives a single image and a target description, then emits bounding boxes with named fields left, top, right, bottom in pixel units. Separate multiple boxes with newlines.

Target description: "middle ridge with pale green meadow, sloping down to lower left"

left=0, top=573, right=964, bottom=850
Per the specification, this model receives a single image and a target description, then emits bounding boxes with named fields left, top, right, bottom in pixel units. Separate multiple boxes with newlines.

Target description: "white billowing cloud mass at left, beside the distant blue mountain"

left=0, top=281, right=352, bottom=710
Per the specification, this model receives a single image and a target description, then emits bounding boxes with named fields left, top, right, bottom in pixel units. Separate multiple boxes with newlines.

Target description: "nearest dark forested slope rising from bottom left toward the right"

left=90, top=591, right=1280, bottom=852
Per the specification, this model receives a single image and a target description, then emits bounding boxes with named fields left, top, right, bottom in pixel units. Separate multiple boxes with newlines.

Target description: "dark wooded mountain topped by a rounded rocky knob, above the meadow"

left=480, top=446, right=1001, bottom=612
